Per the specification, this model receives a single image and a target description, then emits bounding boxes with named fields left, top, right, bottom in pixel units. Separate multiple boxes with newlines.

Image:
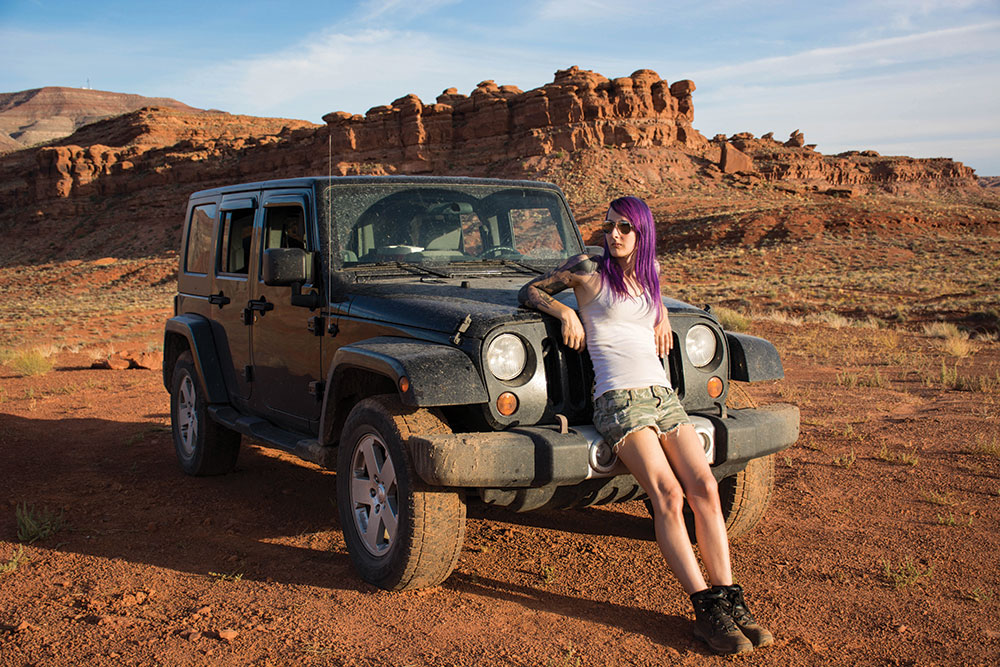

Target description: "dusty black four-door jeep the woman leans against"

left=163, top=177, right=799, bottom=590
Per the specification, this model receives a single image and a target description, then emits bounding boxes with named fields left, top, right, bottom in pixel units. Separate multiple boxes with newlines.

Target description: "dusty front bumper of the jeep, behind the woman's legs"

left=409, top=404, right=799, bottom=489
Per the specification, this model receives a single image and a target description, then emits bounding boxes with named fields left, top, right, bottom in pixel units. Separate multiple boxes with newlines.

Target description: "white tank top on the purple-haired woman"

left=580, top=285, right=670, bottom=398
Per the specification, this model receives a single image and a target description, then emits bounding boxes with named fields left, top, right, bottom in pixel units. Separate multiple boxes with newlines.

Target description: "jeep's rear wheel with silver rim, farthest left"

left=170, top=351, right=240, bottom=476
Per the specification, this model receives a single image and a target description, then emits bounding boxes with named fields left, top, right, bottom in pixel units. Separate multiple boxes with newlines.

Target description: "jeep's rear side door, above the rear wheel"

left=209, top=193, right=258, bottom=403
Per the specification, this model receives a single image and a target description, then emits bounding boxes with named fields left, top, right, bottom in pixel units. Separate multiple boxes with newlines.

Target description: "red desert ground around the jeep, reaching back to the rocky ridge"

left=0, top=184, right=1000, bottom=667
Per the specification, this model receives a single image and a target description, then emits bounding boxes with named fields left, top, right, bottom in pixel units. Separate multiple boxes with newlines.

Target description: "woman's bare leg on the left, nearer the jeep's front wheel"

left=618, top=428, right=708, bottom=594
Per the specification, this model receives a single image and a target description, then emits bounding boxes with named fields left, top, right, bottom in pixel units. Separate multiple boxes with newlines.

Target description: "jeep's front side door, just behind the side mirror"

left=248, top=190, right=323, bottom=433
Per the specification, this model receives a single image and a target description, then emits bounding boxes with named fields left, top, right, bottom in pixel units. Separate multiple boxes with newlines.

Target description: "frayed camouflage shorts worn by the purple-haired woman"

left=594, top=387, right=691, bottom=454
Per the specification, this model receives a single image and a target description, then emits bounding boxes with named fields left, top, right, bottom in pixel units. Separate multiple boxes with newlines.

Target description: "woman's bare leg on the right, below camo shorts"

left=664, top=424, right=733, bottom=586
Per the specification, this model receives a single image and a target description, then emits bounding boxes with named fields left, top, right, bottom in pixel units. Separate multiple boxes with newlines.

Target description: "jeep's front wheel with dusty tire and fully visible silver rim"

left=337, top=396, right=465, bottom=591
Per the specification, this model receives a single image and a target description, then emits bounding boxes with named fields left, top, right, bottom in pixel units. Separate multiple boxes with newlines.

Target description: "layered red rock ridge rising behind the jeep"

left=0, top=67, right=978, bottom=263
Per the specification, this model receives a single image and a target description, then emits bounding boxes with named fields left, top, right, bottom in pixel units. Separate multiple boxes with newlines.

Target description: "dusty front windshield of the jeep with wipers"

left=323, top=183, right=583, bottom=269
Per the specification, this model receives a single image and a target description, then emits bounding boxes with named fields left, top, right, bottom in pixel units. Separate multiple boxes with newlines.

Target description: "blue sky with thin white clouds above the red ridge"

left=0, top=0, right=1000, bottom=176
